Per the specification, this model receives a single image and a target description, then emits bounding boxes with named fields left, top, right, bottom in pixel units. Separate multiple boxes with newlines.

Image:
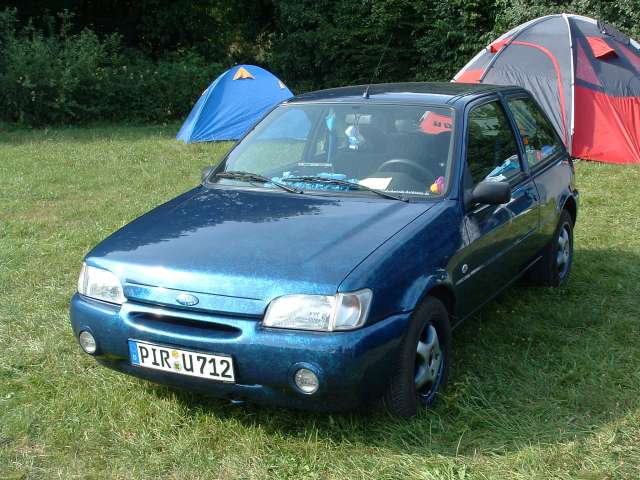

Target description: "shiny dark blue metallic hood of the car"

left=86, top=187, right=432, bottom=315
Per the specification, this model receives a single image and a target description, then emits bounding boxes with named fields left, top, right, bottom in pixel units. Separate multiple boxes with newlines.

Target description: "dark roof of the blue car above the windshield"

left=286, top=82, right=526, bottom=105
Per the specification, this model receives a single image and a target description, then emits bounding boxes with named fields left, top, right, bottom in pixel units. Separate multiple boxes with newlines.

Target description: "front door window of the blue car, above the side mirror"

left=467, top=101, right=522, bottom=185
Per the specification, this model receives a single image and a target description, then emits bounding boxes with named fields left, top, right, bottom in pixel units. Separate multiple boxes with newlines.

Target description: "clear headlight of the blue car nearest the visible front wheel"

left=262, top=289, right=373, bottom=332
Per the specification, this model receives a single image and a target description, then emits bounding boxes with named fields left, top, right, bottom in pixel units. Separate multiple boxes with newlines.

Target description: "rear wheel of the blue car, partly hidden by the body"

left=527, top=210, right=573, bottom=287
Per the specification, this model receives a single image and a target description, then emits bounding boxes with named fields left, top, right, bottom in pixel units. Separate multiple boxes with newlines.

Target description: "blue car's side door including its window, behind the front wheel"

left=454, top=97, right=539, bottom=315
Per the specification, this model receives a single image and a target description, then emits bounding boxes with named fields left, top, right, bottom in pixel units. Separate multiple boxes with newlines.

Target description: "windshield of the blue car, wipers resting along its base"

left=211, top=104, right=453, bottom=197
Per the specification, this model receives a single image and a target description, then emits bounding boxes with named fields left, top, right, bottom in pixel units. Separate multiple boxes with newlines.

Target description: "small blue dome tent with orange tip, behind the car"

left=176, top=65, right=293, bottom=143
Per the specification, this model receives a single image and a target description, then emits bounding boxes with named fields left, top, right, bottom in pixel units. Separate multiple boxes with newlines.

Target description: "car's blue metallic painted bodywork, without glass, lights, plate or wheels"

left=71, top=84, right=577, bottom=409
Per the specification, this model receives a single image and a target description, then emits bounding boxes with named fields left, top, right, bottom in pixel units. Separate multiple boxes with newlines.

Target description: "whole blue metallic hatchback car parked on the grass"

left=71, top=83, right=578, bottom=417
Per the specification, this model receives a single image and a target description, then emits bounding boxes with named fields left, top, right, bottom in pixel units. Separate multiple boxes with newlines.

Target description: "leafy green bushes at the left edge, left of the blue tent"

left=0, top=10, right=221, bottom=125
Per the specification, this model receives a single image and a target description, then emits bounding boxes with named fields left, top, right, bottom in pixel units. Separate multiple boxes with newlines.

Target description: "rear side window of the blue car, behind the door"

left=508, top=98, right=564, bottom=168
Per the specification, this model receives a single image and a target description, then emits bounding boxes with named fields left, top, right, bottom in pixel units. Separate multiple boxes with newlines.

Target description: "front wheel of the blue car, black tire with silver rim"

left=384, top=297, right=451, bottom=418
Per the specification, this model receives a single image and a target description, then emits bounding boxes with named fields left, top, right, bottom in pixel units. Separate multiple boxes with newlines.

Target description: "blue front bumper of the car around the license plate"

left=71, top=294, right=410, bottom=410
